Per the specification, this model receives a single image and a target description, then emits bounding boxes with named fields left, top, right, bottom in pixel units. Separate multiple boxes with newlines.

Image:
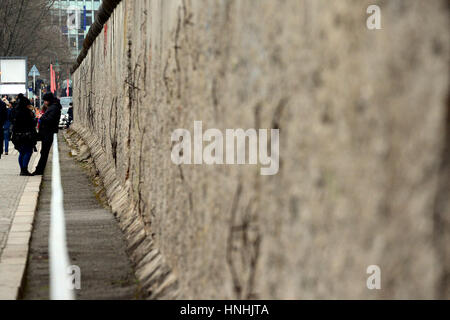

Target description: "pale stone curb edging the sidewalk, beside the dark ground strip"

left=0, top=149, right=42, bottom=300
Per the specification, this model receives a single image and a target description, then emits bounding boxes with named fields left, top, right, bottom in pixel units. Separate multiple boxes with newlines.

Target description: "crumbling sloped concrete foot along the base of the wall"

left=64, top=124, right=179, bottom=299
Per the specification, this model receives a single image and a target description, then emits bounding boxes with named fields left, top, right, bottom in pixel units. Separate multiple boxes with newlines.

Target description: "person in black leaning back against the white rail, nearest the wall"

left=33, top=93, right=62, bottom=176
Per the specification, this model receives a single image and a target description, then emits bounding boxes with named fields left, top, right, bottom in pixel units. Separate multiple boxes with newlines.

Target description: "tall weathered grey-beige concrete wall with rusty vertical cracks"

left=74, top=0, right=450, bottom=299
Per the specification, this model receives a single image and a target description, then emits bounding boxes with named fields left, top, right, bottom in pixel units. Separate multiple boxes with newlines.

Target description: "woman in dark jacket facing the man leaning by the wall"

left=11, top=96, right=37, bottom=176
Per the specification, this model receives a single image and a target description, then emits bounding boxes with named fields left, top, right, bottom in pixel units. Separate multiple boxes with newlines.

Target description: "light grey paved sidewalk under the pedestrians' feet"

left=0, top=144, right=38, bottom=256
